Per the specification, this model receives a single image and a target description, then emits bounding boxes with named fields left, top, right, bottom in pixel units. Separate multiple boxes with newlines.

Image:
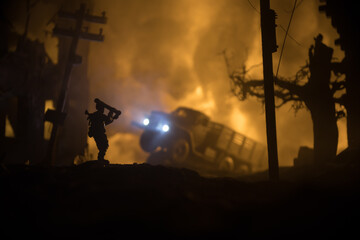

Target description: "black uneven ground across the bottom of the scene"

left=0, top=152, right=360, bottom=239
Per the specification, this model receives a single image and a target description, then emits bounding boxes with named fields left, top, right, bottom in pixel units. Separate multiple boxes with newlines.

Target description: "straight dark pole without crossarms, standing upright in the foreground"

left=260, top=0, right=279, bottom=181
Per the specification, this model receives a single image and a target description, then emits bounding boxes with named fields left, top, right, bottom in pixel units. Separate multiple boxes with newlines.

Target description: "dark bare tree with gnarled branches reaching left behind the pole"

left=225, top=34, right=345, bottom=163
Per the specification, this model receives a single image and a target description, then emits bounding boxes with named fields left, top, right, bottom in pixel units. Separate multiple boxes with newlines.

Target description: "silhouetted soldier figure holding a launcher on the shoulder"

left=85, top=98, right=121, bottom=161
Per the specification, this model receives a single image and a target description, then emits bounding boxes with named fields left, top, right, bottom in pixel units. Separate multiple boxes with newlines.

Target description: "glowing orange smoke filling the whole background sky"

left=4, top=0, right=347, bottom=165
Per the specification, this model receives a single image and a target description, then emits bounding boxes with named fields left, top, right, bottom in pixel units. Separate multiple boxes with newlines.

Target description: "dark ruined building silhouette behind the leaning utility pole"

left=0, top=3, right=93, bottom=165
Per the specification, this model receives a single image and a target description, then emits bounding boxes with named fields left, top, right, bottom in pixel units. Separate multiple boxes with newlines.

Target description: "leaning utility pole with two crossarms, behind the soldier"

left=44, top=4, right=107, bottom=165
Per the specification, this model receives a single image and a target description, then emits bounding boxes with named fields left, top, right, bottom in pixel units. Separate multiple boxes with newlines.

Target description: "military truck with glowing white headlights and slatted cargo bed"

left=133, top=107, right=266, bottom=173
